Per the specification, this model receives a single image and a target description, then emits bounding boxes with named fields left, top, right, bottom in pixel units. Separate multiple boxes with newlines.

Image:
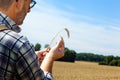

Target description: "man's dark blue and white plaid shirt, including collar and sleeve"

left=0, top=12, right=52, bottom=80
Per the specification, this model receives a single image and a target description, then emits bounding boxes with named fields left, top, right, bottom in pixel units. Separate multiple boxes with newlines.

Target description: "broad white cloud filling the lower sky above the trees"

left=22, top=0, right=120, bottom=55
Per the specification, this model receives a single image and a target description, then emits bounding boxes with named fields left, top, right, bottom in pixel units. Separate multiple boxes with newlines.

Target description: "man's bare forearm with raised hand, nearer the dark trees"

left=41, top=38, right=64, bottom=73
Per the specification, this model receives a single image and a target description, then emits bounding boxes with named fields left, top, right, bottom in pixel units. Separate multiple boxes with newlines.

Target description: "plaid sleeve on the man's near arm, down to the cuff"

left=16, top=42, right=53, bottom=80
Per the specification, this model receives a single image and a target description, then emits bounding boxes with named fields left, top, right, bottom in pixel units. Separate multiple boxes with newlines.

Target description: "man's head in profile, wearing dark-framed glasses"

left=0, top=0, right=36, bottom=25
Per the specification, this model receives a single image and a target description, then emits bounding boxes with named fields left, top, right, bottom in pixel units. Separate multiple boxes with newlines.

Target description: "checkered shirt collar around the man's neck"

left=0, top=12, right=21, bottom=33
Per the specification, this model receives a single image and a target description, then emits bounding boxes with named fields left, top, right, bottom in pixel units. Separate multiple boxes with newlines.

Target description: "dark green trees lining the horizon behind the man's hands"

left=35, top=43, right=120, bottom=66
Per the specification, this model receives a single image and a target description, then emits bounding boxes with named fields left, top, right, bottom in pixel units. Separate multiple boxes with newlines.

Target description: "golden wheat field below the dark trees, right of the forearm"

left=53, top=61, right=120, bottom=80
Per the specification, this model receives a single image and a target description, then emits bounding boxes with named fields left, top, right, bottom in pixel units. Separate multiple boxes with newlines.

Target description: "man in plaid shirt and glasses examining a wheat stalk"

left=0, top=0, right=64, bottom=80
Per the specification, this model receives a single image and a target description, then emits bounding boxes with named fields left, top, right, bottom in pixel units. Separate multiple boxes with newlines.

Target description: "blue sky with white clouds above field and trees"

left=21, top=0, right=120, bottom=56
